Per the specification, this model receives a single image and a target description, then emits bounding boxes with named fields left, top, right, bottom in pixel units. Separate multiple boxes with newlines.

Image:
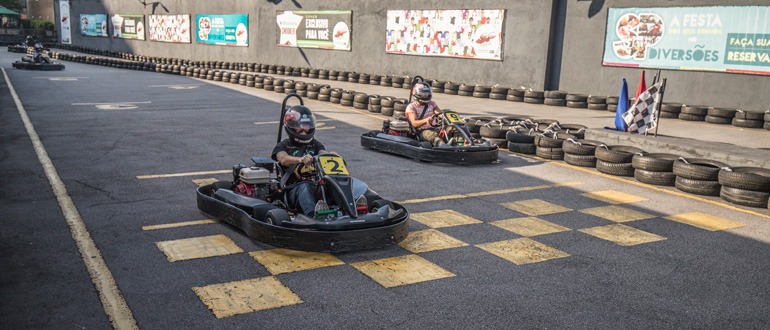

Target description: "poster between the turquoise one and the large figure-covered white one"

left=276, top=10, right=353, bottom=51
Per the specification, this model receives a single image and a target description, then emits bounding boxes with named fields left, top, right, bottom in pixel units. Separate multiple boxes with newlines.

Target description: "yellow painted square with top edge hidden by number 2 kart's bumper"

left=249, top=249, right=345, bottom=275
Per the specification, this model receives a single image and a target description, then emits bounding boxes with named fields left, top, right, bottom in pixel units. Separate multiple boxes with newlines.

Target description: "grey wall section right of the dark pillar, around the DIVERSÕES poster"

left=559, top=0, right=770, bottom=110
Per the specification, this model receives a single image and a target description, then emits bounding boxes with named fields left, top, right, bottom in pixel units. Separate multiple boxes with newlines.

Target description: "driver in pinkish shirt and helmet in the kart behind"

left=404, top=82, right=447, bottom=147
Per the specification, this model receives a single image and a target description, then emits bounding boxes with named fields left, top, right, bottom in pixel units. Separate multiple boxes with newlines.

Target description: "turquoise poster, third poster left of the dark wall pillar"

left=195, top=14, right=249, bottom=47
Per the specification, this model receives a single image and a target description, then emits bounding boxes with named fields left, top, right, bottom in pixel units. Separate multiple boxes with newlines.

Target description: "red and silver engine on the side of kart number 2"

left=233, top=164, right=278, bottom=202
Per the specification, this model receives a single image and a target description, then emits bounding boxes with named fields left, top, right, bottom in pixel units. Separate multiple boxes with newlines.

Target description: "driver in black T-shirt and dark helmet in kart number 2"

left=271, top=105, right=368, bottom=217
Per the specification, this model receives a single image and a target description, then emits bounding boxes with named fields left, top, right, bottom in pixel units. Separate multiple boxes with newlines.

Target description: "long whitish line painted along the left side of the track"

left=0, top=68, right=139, bottom=329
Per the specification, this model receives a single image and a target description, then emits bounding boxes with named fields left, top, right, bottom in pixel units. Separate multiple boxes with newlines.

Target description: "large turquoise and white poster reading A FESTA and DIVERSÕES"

left=602, top=6, right=770, bottom=75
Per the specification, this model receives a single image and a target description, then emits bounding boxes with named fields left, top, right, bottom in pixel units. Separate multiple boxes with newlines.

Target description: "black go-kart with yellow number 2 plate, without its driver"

left=197, top=94, right=409, bottom=252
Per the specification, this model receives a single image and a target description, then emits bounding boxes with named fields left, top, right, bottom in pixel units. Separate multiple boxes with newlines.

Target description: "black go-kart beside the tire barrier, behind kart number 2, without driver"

left=361, top=76, right=499, bottom=165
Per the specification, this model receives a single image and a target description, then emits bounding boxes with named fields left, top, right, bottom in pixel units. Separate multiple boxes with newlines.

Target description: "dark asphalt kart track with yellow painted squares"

left=0, top=52, right=770, bottom=329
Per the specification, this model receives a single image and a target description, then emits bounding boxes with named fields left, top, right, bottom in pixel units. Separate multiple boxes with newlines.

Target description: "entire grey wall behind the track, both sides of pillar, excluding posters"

left=56, top=0, right=770, bottom=110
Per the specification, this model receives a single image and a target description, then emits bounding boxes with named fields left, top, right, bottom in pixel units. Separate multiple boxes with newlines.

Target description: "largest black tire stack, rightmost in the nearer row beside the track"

left=718, top=167, right=770, bottom=208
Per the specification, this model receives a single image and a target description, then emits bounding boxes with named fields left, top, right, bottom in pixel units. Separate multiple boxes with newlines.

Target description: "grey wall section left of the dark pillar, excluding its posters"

left=56, top=0, right=551, bottom=88
